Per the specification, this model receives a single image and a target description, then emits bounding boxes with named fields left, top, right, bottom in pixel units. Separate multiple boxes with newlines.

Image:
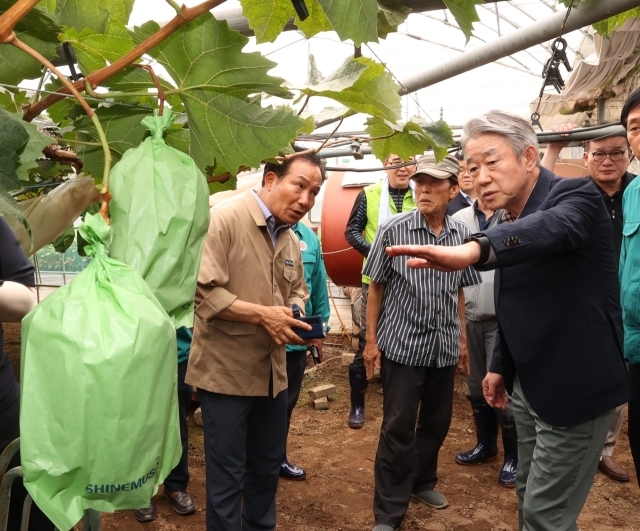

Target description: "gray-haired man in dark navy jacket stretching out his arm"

left=388, top=111, right=632, bottom=531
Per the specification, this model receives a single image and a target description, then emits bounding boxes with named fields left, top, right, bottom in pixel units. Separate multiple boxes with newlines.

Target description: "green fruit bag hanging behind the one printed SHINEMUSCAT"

left=109, top=109, right=209, bottom=328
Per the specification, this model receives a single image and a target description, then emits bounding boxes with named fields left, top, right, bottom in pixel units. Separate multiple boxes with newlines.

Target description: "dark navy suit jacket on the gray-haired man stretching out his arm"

left=479, top=169, right=633, bottom=426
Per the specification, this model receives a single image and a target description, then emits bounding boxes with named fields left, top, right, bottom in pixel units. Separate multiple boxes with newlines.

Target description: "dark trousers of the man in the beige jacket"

left=198, top=389, right=287, bottom=531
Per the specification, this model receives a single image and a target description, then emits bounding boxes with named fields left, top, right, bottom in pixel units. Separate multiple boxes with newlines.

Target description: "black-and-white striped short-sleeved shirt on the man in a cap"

left=363, top=210, right=481, bottom=367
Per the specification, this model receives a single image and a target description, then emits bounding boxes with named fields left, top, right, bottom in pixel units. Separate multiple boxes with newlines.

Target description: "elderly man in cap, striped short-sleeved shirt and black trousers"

left=363, top=155, right=481, bottom=531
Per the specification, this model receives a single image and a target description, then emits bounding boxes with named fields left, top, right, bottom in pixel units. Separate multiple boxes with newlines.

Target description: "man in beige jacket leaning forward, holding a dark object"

left=186, top=155, right=324, bottom=531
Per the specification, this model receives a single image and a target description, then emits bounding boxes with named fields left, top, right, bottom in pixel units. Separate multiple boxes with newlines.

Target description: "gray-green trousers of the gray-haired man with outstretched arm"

left=512, top=376, right=614, bottom=531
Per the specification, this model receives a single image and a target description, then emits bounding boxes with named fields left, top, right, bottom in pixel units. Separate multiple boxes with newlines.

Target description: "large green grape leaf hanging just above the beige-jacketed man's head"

left=134, top=13, right=304, bottom=173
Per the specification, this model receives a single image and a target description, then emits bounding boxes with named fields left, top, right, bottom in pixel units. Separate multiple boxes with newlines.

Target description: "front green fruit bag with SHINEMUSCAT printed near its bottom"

left=20, top=215, right=182, bottom=531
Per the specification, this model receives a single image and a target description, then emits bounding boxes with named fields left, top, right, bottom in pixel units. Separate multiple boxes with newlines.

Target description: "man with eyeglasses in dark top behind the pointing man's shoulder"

left=541, top=124, right=635, bottom=482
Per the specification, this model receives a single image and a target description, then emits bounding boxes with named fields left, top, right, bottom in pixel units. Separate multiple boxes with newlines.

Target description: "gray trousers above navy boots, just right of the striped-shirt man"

left=466, top=317, right=513, bottom=417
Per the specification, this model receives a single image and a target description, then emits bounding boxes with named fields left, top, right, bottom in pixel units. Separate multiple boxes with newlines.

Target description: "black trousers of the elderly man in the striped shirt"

left=373, top=357, right=456, bottom=527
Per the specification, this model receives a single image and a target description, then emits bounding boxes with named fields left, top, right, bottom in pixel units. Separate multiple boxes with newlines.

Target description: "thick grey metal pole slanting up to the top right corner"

left=399, top=0, right=640, bottom=95
